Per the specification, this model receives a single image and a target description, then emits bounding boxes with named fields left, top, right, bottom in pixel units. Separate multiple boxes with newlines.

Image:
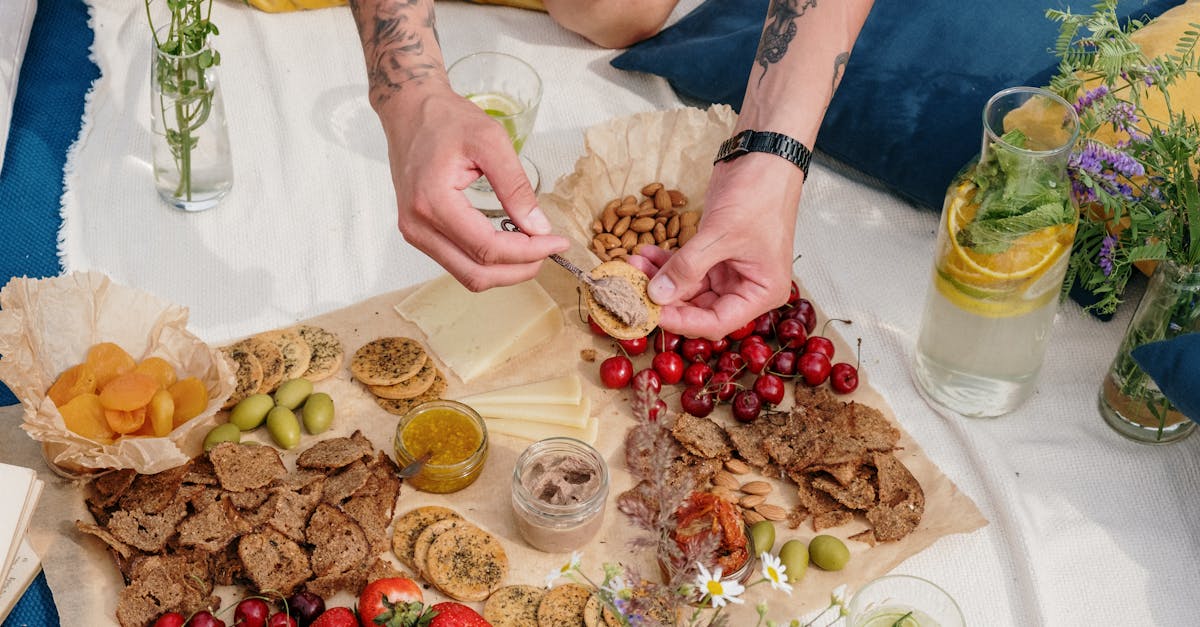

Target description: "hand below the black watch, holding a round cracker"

left=629, top=154, right=803, bottom=339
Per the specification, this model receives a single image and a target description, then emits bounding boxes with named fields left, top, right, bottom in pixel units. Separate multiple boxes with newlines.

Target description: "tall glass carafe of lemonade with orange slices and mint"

left=914, top=88, right=1079, bottom=417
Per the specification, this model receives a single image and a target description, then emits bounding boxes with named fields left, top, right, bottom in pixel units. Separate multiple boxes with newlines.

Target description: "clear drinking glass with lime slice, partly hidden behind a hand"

left=446, top=52, right=541, bottom=217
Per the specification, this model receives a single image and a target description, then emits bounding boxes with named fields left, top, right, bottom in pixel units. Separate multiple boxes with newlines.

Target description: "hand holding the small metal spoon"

left=379, top=82, right=569, bottom=292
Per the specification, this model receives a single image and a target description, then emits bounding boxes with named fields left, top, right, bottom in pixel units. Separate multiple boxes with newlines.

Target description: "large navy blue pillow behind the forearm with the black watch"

left=612, top=0, right=1182, bottom=210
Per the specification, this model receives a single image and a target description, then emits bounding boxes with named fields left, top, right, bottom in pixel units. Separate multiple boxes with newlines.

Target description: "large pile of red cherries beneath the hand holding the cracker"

left=588, top=281, right=858, bottom=423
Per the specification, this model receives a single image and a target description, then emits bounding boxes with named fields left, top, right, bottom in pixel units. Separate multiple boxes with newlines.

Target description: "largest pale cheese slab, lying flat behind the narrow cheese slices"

left=396, top=274, right=563, bottom=382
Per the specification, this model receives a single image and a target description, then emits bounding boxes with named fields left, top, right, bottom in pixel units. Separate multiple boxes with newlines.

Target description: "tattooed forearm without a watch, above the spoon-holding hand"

left=350, top=0, right=438, bottom=106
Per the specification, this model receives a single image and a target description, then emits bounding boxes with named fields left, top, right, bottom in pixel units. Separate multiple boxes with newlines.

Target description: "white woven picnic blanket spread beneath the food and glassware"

left=18, top=0, right=1200, bottom=626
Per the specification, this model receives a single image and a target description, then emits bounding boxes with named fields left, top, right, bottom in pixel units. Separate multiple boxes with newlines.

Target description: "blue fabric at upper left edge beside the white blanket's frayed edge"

left=0, top=0, right=100, bottom=406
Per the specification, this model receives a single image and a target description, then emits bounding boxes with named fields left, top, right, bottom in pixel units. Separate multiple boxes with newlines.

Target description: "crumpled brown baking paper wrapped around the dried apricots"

left=0, top=273, right=235, bottom=473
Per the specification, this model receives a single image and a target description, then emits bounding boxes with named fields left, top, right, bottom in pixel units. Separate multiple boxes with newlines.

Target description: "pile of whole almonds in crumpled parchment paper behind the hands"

left=592, top=183, right=700, bottom=261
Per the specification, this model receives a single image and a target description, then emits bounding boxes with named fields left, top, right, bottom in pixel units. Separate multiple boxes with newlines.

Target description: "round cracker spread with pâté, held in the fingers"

left=583, top=259, right=662, bottom=340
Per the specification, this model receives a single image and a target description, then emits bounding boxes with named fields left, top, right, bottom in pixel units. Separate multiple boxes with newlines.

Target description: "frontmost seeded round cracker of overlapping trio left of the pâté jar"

left=426, top=526, right=506, bottom=602
